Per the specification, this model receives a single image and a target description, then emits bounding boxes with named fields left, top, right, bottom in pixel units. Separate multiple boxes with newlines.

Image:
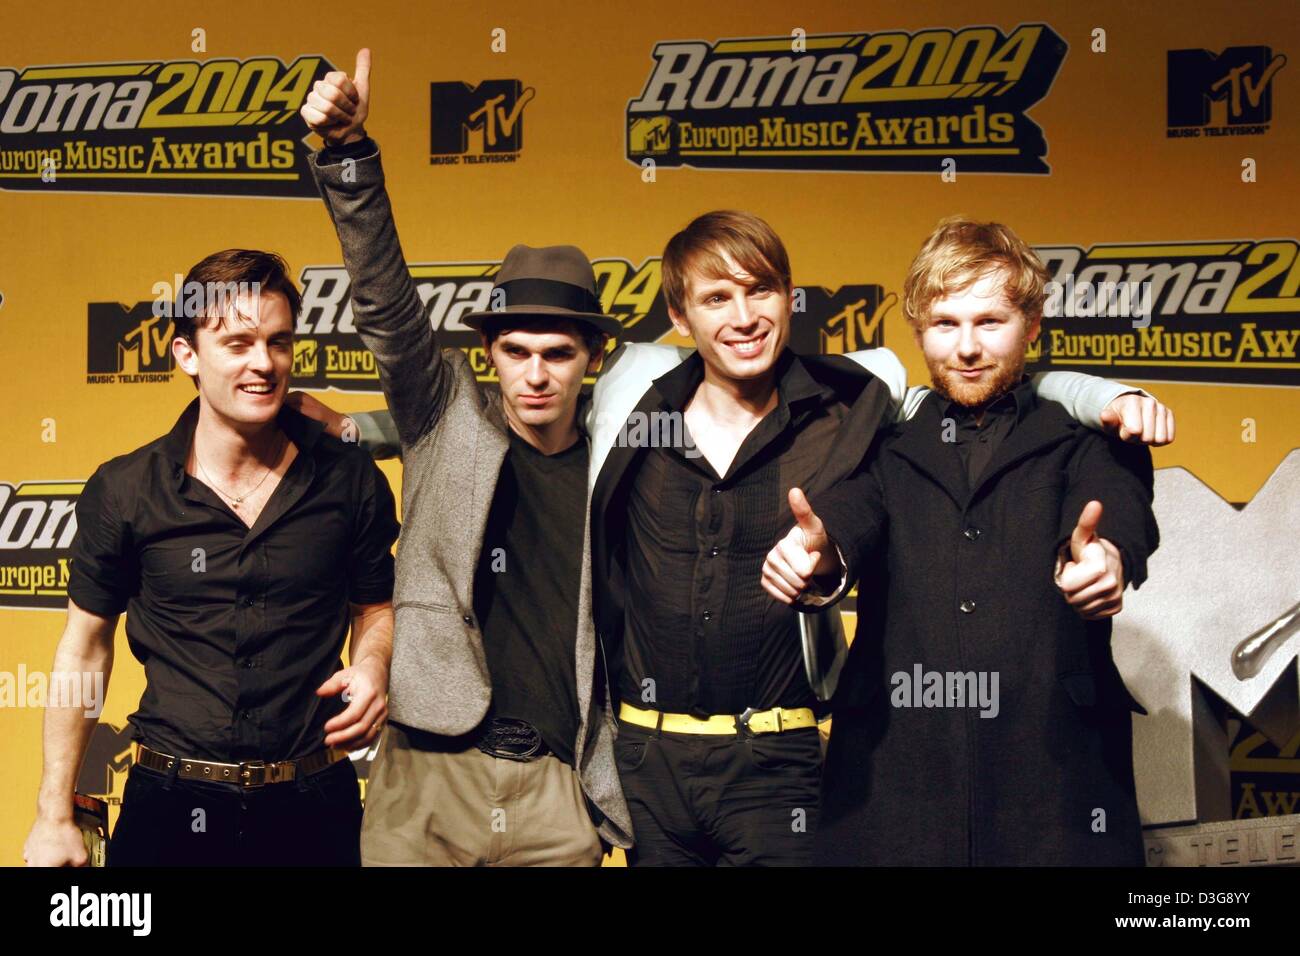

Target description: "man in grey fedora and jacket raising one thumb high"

left=299, top=51, right=632, bottom=865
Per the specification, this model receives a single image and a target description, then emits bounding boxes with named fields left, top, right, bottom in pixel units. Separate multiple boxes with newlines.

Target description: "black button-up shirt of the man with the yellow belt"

left=619, top=351, right=848, bottom=715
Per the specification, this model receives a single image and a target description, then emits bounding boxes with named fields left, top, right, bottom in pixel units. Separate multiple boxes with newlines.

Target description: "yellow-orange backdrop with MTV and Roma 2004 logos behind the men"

left=0, top=0, right=1300, bottom=864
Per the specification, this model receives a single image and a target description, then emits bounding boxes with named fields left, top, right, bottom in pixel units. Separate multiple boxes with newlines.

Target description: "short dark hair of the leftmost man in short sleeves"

left=172, top=248, right=303, bottom=349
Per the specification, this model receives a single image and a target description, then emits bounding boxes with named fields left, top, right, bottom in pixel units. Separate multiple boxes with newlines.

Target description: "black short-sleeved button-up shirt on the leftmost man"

left=68, top=399, right=398, bottom=762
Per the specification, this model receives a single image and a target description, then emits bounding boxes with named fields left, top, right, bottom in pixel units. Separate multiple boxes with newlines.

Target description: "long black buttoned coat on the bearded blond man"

left=811, top=394, right=1158, bottom=865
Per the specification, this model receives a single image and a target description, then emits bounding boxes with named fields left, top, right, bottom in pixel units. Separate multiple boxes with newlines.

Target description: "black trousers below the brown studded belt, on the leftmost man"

left=105, top=760, right=361, bottom=866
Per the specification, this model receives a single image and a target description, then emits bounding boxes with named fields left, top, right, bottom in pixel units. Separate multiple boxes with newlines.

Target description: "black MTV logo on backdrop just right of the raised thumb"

left=429, top=79, right=537, bottom=156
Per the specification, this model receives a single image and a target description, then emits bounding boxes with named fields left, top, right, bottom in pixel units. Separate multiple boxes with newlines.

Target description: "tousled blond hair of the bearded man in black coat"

left=902, top=216, right=1049, bottom=326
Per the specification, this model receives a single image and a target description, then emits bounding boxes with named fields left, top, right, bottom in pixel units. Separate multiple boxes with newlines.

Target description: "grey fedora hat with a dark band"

left=462, top=245, right=623, bottom=336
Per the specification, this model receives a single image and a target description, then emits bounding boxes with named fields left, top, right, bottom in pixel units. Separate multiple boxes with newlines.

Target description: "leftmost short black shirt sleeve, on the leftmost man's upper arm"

left=68, top=466, right=140, bottom=618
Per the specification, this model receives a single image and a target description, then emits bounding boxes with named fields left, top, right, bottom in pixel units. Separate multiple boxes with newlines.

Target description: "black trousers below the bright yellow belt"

left=614, top=722, right=822, bottom=866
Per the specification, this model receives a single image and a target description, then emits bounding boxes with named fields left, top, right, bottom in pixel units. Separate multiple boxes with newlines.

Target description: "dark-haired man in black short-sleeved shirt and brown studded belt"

left=23, top=250, right=398, bottom=866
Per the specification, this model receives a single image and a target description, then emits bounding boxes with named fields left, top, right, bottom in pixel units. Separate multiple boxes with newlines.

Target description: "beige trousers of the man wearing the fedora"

left=361, top=723, right=602, bottom=866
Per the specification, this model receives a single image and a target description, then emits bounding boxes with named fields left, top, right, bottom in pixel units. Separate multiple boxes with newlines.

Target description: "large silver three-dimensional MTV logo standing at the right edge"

left=1102, top=449, right=1300, bottom=826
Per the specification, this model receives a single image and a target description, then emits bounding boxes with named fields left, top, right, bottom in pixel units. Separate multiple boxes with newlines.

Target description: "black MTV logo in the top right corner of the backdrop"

left=1166, top=46, right=1287, bottom=126
